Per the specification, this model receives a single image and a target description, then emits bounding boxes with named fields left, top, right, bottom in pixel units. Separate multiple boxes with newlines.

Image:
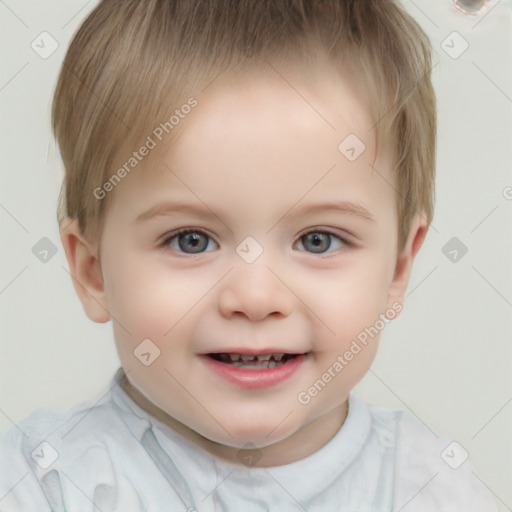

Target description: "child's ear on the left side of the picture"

left=60, top=219, right=110, bottom=323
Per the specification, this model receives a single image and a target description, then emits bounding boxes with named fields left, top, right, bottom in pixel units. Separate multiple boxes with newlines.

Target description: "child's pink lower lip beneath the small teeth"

left=202, top=354, right=306, bottom=389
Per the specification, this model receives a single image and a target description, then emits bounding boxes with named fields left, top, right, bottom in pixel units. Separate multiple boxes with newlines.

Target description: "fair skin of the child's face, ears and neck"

left=62, top=61, right=427, bottom=467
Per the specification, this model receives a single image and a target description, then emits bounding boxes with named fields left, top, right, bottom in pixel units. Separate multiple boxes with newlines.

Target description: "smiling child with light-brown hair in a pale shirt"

left=0, top=0, right=496, bottom=512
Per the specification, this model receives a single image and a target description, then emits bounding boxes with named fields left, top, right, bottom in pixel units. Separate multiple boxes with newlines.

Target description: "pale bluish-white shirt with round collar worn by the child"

left=0, top=368, right=498, bottom=512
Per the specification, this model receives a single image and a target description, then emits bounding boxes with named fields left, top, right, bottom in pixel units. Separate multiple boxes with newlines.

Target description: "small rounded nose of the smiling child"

left=219, top=257, right=294, bottom=322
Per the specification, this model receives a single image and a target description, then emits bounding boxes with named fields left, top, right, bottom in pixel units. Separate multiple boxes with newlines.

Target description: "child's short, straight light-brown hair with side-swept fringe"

left=52, top=0, right=436, bottom=247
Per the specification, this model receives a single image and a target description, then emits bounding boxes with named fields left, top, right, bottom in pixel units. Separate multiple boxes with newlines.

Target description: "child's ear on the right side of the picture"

left=388, top=214, right=428, bottom=316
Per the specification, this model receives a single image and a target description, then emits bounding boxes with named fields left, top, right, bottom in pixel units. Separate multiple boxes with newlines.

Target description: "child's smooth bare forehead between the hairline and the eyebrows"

left=105, top=64, right=394, bottom=227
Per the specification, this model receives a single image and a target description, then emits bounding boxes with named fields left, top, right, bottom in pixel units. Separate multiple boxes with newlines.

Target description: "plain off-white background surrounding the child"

left=0, top=0, right=512, bottom=510
